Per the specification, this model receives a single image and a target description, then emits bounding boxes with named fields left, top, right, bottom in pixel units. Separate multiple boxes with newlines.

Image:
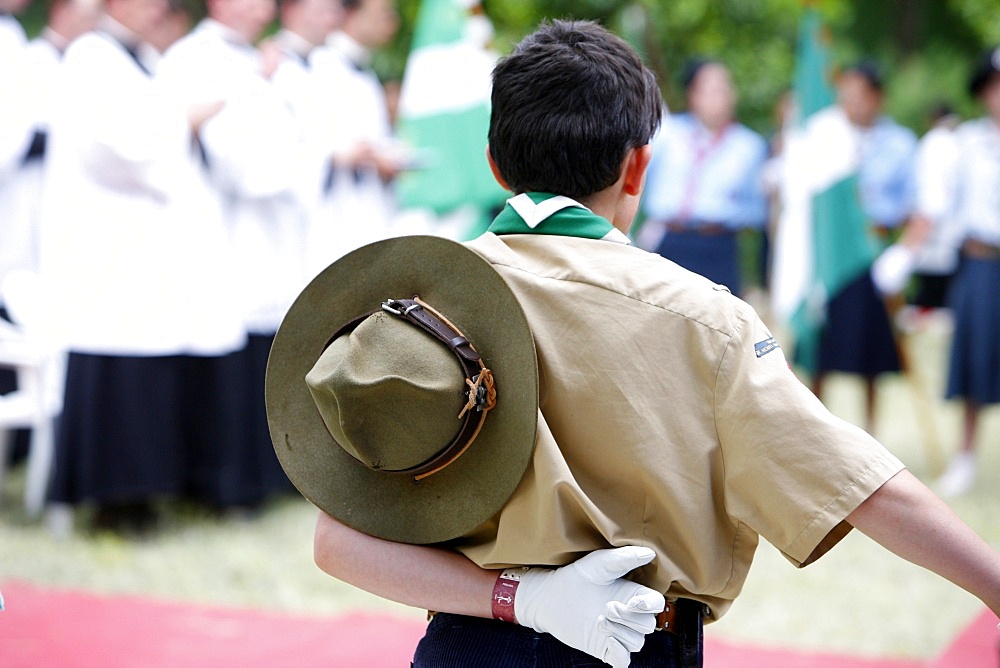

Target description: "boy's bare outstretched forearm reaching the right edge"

left=847, top=470, right=1000, bottom=616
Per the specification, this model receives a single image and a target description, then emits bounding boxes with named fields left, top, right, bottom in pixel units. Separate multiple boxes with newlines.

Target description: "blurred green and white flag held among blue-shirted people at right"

left=771, top=8, right=878, bottom=373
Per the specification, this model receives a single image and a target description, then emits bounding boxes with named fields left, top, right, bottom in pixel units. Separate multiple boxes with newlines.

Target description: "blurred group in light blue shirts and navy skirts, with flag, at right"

left=636, top=48, right=1000, bottom=497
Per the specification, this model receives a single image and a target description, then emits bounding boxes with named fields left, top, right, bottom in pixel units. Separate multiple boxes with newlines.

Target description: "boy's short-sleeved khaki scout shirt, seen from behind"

left=453, top=233, right=903, bottom=618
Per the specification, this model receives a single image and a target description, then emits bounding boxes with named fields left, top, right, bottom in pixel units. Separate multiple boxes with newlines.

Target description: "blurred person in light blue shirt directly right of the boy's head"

left=638, top=60, right=768, bottom=295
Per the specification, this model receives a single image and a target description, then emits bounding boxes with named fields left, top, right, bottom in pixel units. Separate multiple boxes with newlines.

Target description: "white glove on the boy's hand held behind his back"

left=514, top=545, right=666, bottom=668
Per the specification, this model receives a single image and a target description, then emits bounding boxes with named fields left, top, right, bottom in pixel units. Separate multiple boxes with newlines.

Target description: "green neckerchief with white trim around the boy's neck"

left=487, top=193, right=631, bottom=244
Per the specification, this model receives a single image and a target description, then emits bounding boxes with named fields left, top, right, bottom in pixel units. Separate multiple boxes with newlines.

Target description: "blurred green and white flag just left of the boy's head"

left=397, top=0, right=510, bottom=236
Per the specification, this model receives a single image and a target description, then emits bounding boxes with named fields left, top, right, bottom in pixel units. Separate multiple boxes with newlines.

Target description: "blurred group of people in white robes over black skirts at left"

left=0, top=0, right=438, bottom=529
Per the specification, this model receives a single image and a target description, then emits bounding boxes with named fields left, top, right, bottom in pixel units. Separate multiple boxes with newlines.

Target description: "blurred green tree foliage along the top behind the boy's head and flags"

left=380, top=0, right=1000, bottom=133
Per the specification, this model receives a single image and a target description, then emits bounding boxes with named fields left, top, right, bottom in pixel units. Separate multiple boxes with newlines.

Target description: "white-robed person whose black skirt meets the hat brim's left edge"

left=157, top=0, right=318, bottom=509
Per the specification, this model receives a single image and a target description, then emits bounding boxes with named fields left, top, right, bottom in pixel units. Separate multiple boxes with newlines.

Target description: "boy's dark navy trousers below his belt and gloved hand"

left=412, top=602, right=703, bottom=668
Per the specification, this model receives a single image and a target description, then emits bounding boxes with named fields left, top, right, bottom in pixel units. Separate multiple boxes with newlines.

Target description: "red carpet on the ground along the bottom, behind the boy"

left=0, top=581, right=1000, bottom=668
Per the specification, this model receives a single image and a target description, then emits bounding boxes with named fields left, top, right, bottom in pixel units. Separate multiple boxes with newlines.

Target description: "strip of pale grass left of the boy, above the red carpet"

left=0, top=486, right=422, bottom=615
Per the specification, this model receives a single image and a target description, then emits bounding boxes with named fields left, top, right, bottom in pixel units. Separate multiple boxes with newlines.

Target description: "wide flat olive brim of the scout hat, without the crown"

left=265, top=236, right=538, bottom=544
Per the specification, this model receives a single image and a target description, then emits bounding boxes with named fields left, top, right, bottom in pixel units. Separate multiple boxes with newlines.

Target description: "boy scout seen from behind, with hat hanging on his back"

left=268, top=21, right=1000, bottom=666
